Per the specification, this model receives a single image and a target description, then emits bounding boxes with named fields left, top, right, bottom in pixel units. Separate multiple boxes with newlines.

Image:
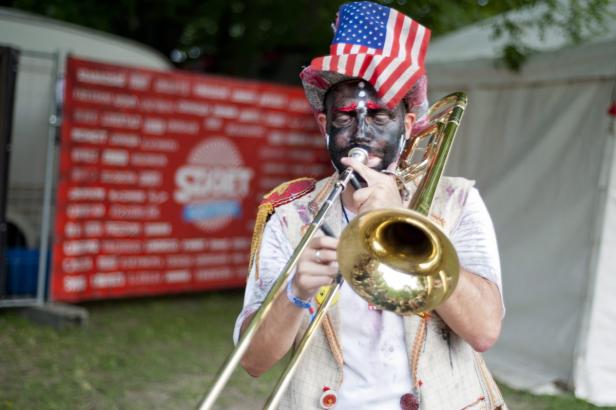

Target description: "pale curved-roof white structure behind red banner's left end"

left=0, top=7, right=171, bottom=247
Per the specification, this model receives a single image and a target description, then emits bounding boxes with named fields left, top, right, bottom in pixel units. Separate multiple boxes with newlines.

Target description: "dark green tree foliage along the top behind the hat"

left=0, top=0, right=613, bottom=79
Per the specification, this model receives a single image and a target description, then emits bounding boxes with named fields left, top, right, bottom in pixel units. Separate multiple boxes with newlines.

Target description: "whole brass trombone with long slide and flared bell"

left=199, top=93, right=467, bottom=409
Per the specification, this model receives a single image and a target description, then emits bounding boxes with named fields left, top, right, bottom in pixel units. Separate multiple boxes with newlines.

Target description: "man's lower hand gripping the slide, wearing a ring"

left=292, top=236, right=338, bottom=300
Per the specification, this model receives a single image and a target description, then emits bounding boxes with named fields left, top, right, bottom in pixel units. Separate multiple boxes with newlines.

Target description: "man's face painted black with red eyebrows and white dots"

left=325, top=80, right=406, bottom=171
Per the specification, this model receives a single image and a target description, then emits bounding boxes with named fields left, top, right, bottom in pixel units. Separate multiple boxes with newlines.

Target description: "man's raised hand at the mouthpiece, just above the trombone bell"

left=341, top=157, right=404, bottom=214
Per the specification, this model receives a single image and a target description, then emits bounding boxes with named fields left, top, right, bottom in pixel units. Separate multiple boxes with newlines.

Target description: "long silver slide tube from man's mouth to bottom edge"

left=199, top=167, right=353, bottom=410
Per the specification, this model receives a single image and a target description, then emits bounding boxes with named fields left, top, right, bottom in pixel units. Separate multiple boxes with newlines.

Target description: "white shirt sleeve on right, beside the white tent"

left=451, top=188, right=504, bottom=307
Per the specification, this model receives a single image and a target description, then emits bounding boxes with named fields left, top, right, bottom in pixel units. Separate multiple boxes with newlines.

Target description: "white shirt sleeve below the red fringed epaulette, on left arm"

left=233, top=213, right=293, bottom=344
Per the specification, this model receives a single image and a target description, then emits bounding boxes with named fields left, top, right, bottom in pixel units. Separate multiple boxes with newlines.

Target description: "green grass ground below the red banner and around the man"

left=0, top=291, right=612, bottom=410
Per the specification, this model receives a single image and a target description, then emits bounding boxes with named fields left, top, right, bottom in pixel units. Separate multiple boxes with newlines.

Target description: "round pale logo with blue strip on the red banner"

left=174, top=137, right=254, bottom=232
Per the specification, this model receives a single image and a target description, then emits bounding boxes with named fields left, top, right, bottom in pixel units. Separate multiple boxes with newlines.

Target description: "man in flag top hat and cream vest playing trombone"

left=234, top=2, right=505, bottom=410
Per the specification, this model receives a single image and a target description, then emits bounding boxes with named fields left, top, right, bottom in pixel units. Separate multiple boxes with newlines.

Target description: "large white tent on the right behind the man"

left=428, top=4, right=616, bottom=405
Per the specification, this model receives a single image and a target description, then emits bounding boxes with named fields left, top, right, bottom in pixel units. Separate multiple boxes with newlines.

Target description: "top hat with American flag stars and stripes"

left=300, top=1, right=430, bottom=118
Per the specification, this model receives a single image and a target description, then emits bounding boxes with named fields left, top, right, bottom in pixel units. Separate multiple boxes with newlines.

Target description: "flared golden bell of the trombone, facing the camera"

left=338, top=209, right=460, bottom=315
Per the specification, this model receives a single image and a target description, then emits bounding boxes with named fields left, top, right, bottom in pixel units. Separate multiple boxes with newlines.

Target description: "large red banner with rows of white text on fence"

left=51, top=58, right=331, bottom=301
